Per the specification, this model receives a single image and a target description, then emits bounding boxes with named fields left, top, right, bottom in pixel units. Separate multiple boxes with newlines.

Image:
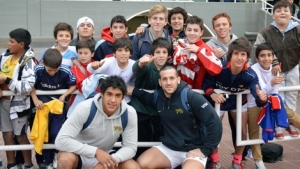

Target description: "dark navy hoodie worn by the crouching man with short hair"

left=132, top=81, right=222, bottom=157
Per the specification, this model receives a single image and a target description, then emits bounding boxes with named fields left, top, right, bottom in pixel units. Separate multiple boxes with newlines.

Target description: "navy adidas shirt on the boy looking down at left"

left=34, top=65, right=76, bottom=103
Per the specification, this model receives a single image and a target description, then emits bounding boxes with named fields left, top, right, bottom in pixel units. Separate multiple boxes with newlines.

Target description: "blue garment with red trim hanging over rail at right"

left=257, top=94, right=289, bottom=143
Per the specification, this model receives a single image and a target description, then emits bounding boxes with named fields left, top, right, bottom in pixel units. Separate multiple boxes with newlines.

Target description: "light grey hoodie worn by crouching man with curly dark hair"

left=55, top=94, right=137, bottom=163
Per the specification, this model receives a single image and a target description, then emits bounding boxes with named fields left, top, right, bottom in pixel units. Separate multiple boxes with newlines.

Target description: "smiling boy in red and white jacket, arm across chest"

left=173, top=15, right=222, bottom=89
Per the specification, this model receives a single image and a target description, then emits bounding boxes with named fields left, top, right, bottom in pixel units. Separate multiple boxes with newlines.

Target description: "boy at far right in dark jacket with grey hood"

left=254, top=0, right=300, bottom=136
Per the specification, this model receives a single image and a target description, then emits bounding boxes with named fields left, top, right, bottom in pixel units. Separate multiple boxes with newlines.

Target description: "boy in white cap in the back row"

left=70, top=16, right=96, bottom=46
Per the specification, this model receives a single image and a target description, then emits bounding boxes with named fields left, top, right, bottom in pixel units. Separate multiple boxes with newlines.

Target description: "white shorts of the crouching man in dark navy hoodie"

left=153, top=144, right=207, bottom=168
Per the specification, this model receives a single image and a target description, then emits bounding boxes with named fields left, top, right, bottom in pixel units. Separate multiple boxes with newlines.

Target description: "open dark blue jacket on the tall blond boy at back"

left=130, top=27, right=173, bottom=60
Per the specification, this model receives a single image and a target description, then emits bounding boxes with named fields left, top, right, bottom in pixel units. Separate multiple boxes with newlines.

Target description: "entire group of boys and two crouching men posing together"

left=0, top=0, right=300, bottom=169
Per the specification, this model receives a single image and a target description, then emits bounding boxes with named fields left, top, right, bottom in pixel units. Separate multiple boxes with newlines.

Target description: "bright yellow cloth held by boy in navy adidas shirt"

left=29, top=99, right=64, bottom=154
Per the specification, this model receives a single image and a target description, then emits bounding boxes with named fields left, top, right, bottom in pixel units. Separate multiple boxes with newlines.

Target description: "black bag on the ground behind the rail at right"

left=261, top=143, right=283, bottom=163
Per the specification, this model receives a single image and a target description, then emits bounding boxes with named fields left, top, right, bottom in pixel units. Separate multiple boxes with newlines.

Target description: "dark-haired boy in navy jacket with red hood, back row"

left=94, top=15, right=128, bottom=61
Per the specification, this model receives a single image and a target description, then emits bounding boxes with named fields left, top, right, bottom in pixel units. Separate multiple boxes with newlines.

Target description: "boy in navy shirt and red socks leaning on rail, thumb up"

left=203, top=37, right=267, bottom=169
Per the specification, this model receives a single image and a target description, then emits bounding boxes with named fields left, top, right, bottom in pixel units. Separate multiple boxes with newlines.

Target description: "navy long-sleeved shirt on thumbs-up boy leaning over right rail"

left=202, top=61, right=265, bottom=111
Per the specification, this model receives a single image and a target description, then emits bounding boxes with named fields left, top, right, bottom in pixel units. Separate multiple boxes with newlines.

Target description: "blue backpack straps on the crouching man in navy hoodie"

left=154, top=87, right=206, bottom=136
